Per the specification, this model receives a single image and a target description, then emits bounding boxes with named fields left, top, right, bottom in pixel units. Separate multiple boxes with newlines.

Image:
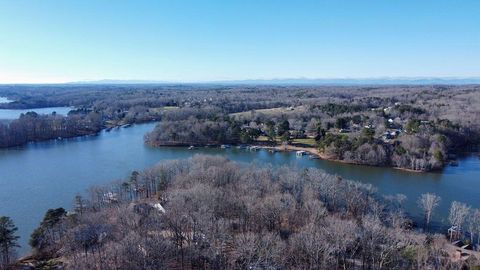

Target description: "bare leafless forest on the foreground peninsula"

left=0, top=155, right=480, bottom=269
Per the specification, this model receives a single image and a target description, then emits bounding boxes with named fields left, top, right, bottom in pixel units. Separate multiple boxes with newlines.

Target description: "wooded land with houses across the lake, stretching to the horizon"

left=0, top=84, right=480, bottom=171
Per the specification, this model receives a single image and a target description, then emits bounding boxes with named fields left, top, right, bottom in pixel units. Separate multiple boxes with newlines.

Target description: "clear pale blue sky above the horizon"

left=0, top=0, right=480, bottom=83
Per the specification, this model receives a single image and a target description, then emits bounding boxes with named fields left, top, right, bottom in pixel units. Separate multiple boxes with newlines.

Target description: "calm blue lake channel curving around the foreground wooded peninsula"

left=0, top=123, right=480, bottom=253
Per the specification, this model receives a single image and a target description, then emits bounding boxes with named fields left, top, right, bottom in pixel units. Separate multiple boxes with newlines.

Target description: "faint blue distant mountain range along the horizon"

left=67, top=77, right=480, bottom=85
